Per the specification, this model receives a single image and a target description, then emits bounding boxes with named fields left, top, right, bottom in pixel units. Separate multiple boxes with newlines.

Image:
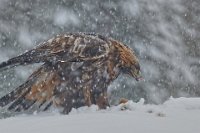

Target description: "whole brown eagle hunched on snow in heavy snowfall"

left=0, top=33, right=141, bottom=114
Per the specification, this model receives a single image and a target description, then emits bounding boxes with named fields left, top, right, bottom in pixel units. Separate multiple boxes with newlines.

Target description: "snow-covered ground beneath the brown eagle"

left=0, top=98, right=200, bottom=133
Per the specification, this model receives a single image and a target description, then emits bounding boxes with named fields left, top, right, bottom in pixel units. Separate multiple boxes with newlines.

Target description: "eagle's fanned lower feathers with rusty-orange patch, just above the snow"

left=0, top=64, right=60, bottom=112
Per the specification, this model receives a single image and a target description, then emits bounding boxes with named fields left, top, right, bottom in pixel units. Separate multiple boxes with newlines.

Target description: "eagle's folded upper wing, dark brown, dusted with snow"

left=0, top=33, right=109, bottom=70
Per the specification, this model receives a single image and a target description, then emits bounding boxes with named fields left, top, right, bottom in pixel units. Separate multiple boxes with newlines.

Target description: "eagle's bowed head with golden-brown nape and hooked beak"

left=113, top=42, right=143, bottom=81
